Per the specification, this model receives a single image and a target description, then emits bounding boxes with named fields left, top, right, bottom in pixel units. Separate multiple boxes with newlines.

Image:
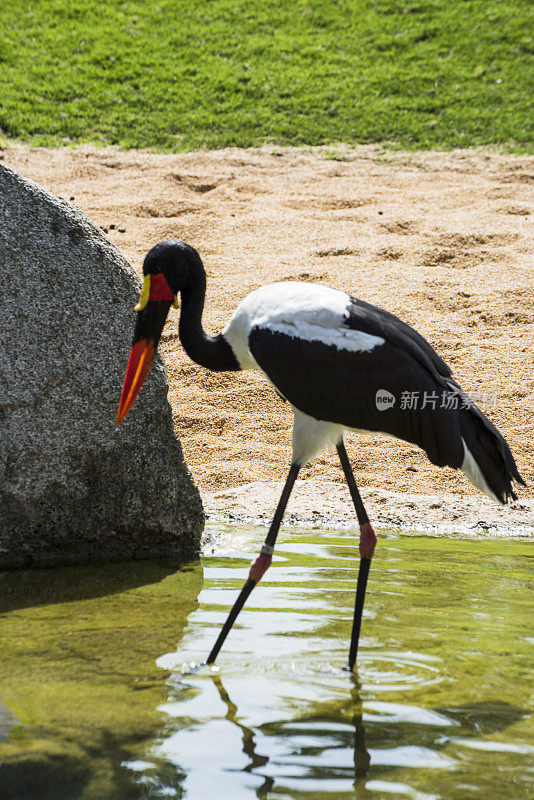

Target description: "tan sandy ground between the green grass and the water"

left=3, top=145, right=534, bottom=530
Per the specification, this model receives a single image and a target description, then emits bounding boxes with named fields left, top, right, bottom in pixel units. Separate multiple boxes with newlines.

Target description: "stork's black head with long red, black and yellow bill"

left=117, top=240, right=204, bottom=425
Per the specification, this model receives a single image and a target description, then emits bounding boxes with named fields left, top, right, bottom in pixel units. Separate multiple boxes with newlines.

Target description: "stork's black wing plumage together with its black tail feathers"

left=249, top=297, right=524, bottom=503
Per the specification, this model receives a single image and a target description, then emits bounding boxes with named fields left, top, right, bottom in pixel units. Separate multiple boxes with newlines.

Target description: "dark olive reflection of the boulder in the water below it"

left=0, top=561, right=202, bottom=800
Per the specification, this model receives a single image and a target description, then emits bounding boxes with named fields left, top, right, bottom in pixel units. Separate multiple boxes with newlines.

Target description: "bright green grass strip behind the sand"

left=0, top=0, right=534, bottom=151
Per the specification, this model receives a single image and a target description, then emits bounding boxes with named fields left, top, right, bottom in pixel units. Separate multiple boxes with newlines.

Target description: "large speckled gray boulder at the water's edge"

left=0, top=165, right=204, bottom=567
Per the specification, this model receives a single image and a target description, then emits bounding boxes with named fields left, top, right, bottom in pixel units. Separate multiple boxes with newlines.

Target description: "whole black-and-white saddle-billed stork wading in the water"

left=117, top=240, right=525, bottom=669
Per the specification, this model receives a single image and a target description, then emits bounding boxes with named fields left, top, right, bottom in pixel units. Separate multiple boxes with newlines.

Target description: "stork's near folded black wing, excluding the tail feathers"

left=249, top=318, right=463, bottom=467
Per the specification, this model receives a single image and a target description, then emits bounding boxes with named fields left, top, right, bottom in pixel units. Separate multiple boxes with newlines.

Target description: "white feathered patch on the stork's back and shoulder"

left=223, top=281, right=384, bottom=369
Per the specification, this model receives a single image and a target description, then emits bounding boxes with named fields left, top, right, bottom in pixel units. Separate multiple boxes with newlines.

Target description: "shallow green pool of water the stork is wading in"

left=0, top=529, right=534, bottom=800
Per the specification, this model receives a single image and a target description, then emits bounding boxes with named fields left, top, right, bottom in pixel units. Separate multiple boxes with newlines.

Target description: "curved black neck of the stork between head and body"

left=179, top=282, right=241, bottom=372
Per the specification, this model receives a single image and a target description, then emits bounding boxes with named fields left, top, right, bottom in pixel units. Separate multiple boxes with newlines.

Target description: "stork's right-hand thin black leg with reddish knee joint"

left=337, top=439, right=376, bottom=671
